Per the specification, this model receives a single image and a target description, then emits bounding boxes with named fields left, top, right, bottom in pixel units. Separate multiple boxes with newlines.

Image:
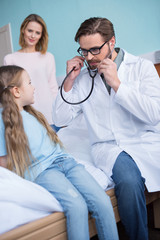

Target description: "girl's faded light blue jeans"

left=35, top=158, right=118, bottom=240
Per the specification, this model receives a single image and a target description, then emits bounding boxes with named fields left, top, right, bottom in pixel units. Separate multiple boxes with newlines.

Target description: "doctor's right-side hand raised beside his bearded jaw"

left=98, top=58, right=121, bottom=92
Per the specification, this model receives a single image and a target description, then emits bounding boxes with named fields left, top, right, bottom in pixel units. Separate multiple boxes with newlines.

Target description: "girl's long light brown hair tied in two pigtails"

left=0, top=65, right=62, bottom=177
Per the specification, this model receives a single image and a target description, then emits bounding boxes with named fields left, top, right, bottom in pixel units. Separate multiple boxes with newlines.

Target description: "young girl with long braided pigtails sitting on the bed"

left=0, top=66, right=118, bottom=240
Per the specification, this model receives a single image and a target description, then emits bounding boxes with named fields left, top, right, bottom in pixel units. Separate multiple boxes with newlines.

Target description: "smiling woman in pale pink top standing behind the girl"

left=4, top=14, right=58, bottom=125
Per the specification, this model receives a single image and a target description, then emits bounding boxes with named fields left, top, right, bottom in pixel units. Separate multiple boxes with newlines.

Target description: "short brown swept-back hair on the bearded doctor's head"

left=74, top=17, right=115, bottom=42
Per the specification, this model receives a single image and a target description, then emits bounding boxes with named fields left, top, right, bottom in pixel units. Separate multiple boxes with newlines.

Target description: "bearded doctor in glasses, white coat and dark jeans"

left=53, top=18, right=160, bottom=240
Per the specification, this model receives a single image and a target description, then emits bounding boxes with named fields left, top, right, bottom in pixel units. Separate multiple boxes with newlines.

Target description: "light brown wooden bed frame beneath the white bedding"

left=0, top=189, right=160, bottom=240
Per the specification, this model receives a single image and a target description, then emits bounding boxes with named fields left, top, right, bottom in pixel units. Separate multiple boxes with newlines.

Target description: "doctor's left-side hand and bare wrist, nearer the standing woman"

left=64, top=56, right=84, bottom=92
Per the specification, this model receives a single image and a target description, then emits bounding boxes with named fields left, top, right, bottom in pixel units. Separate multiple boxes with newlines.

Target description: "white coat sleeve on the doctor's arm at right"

left=115, top=60, right=160, bottom=125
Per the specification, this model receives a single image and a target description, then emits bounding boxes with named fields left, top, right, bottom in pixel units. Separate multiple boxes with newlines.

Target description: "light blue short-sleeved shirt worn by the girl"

left=0, top=109, right=70, bottom=181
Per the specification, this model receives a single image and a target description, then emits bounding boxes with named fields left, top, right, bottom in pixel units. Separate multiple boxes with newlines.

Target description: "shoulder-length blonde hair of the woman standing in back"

left=19, top=14, right=48, bottom=54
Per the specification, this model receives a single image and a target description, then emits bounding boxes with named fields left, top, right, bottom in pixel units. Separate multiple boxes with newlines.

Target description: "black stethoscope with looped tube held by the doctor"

left=60, top=48, right=114, bottom=105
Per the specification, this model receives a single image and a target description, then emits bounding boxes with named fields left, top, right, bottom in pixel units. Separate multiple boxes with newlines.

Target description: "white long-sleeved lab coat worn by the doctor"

left=53, top=52, right=160, bottom=192
